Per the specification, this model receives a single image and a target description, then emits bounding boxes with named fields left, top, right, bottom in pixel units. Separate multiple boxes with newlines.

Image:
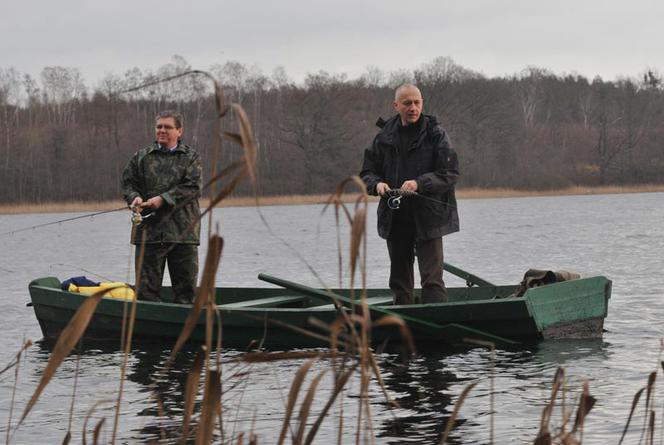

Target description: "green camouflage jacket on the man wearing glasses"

left=122, top=142, right=202, bottom=244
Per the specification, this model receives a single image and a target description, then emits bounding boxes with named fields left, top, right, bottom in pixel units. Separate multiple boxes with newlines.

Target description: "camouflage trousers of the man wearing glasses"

left=136, top=243, right=198, bottom=303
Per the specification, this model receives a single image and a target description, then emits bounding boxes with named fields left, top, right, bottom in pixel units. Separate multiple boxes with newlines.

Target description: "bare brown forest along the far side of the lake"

left=0, top=56, right=664, bottom=203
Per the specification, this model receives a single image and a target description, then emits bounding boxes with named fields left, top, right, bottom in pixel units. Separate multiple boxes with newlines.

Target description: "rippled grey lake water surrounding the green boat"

left=0, top=193, right=664, bottom=444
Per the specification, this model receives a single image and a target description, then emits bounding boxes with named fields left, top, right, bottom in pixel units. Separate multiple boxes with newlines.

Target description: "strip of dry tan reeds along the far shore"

left=0, top=184, right=664, bottom=215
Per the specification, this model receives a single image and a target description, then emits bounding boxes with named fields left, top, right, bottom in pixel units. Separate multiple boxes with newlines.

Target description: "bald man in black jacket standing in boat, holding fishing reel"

left=360, top=84, right=459, bottom=304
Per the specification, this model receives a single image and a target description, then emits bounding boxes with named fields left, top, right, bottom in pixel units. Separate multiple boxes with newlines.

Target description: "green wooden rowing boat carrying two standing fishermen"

left=29, top=265, right=611, bottom=349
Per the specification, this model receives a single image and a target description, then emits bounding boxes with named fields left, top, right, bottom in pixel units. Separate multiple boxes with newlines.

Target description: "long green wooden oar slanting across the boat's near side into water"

left=258, top=273, right=518, bottom=345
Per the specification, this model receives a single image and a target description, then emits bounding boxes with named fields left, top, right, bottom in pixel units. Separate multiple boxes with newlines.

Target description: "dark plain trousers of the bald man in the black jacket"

left=387, top=230, right=447, bottom=304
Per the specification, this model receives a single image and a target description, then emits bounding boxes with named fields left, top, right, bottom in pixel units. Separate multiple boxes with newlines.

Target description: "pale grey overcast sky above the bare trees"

left=0, top=0, right=664, bottom=84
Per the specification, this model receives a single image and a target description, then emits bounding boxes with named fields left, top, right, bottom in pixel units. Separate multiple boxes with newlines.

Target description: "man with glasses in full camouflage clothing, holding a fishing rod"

left=122, top=111, right=202, bottom=303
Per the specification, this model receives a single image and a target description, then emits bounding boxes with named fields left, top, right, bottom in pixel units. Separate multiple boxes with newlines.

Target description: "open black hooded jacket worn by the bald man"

left=360, top=115, right=459, bottom=241
